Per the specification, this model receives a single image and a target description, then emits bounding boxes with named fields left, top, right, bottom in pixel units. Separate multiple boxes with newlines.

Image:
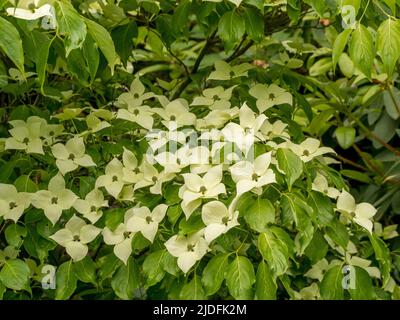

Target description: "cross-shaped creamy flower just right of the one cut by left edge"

left=32, top=173, right=78, bottom=224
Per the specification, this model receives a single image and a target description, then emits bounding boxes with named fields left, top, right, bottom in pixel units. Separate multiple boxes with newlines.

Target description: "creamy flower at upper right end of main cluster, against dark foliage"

left=249, top=84, right=293, bottom=113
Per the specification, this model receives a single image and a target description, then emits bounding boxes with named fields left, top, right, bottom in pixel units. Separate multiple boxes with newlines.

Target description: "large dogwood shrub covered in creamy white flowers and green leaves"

left=0, top=1, right=400, bottom=299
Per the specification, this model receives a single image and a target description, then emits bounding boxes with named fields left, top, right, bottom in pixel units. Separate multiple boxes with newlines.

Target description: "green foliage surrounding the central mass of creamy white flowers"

left=0, top=0, right=400, bottom=299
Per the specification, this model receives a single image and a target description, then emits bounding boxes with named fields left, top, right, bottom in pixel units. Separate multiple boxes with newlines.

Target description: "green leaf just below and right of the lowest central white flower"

left=201, top=253, right=229, bottom=296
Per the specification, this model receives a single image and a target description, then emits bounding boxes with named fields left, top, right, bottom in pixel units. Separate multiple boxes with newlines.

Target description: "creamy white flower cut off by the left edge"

left=0, top=183, right=31, bottom=222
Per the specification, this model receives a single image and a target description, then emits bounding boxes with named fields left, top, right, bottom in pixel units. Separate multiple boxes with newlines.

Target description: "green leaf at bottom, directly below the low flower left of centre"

left=111, top=257, right=140, bottom=300
